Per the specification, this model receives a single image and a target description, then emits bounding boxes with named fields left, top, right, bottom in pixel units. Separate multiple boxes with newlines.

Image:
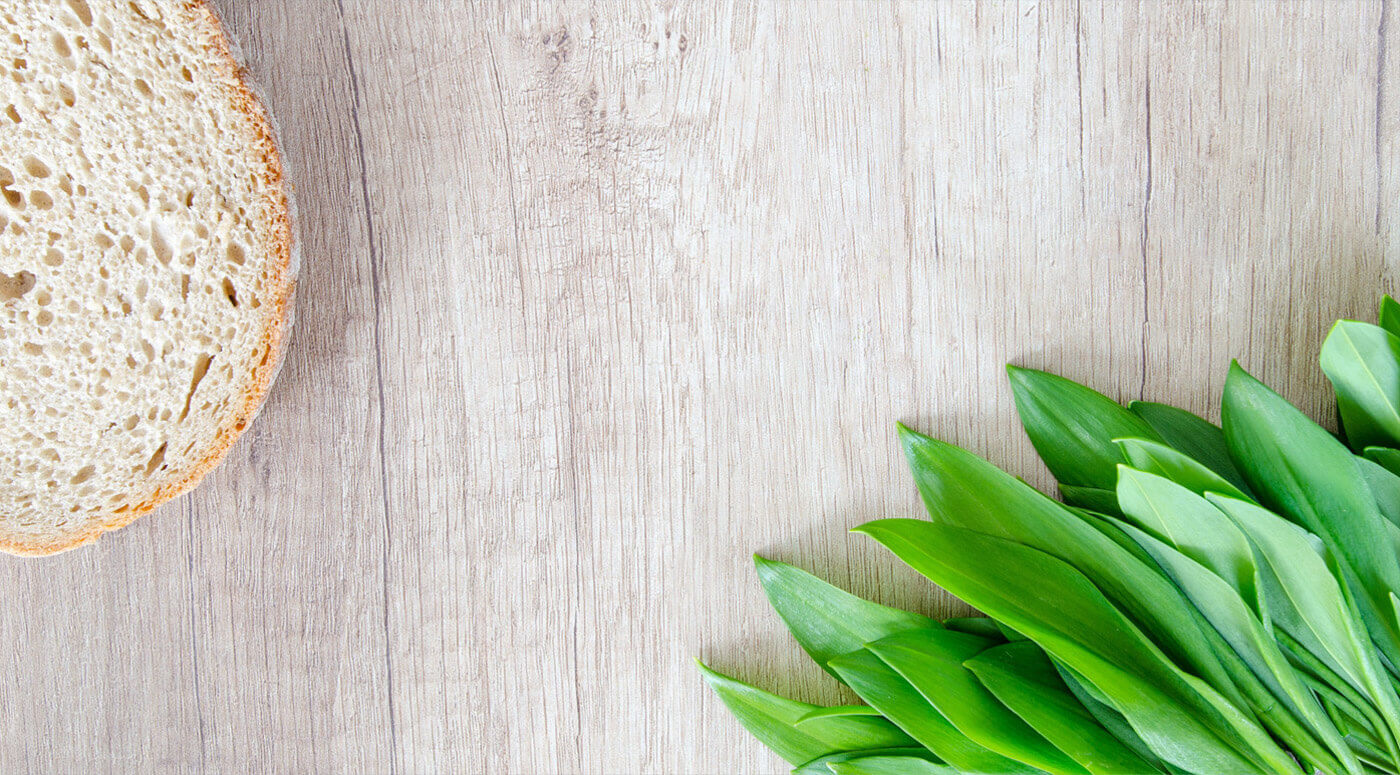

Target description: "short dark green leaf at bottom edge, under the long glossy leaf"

left=963, top=641, right=1159, bottom=775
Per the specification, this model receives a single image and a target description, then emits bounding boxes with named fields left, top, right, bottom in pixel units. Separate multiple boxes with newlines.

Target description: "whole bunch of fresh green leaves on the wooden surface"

left=701, top=297, right=1400, bottom=775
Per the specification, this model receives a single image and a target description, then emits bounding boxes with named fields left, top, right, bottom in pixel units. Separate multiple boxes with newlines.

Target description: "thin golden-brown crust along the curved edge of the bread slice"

left=0, top=0, right=297, bottom=557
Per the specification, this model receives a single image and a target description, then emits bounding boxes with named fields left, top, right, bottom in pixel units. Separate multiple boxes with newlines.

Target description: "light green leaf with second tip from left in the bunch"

left=753, top=555, right=938, bottom=676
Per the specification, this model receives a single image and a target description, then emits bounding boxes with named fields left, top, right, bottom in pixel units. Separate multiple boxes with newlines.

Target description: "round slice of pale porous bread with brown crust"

left=0, top=0, right=295, bottom=554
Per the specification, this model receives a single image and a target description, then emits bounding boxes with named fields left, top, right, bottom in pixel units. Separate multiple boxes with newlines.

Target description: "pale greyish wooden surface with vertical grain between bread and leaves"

left=0, top=0, right=1400, bottom=774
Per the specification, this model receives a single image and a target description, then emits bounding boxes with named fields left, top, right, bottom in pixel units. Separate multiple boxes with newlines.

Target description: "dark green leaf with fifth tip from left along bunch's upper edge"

left=1007, top=367, right=1158, bottom=490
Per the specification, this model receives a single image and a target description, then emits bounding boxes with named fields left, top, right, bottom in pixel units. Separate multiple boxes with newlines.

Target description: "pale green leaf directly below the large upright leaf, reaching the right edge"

left=1207, top=494, right=1400, bottom=749
